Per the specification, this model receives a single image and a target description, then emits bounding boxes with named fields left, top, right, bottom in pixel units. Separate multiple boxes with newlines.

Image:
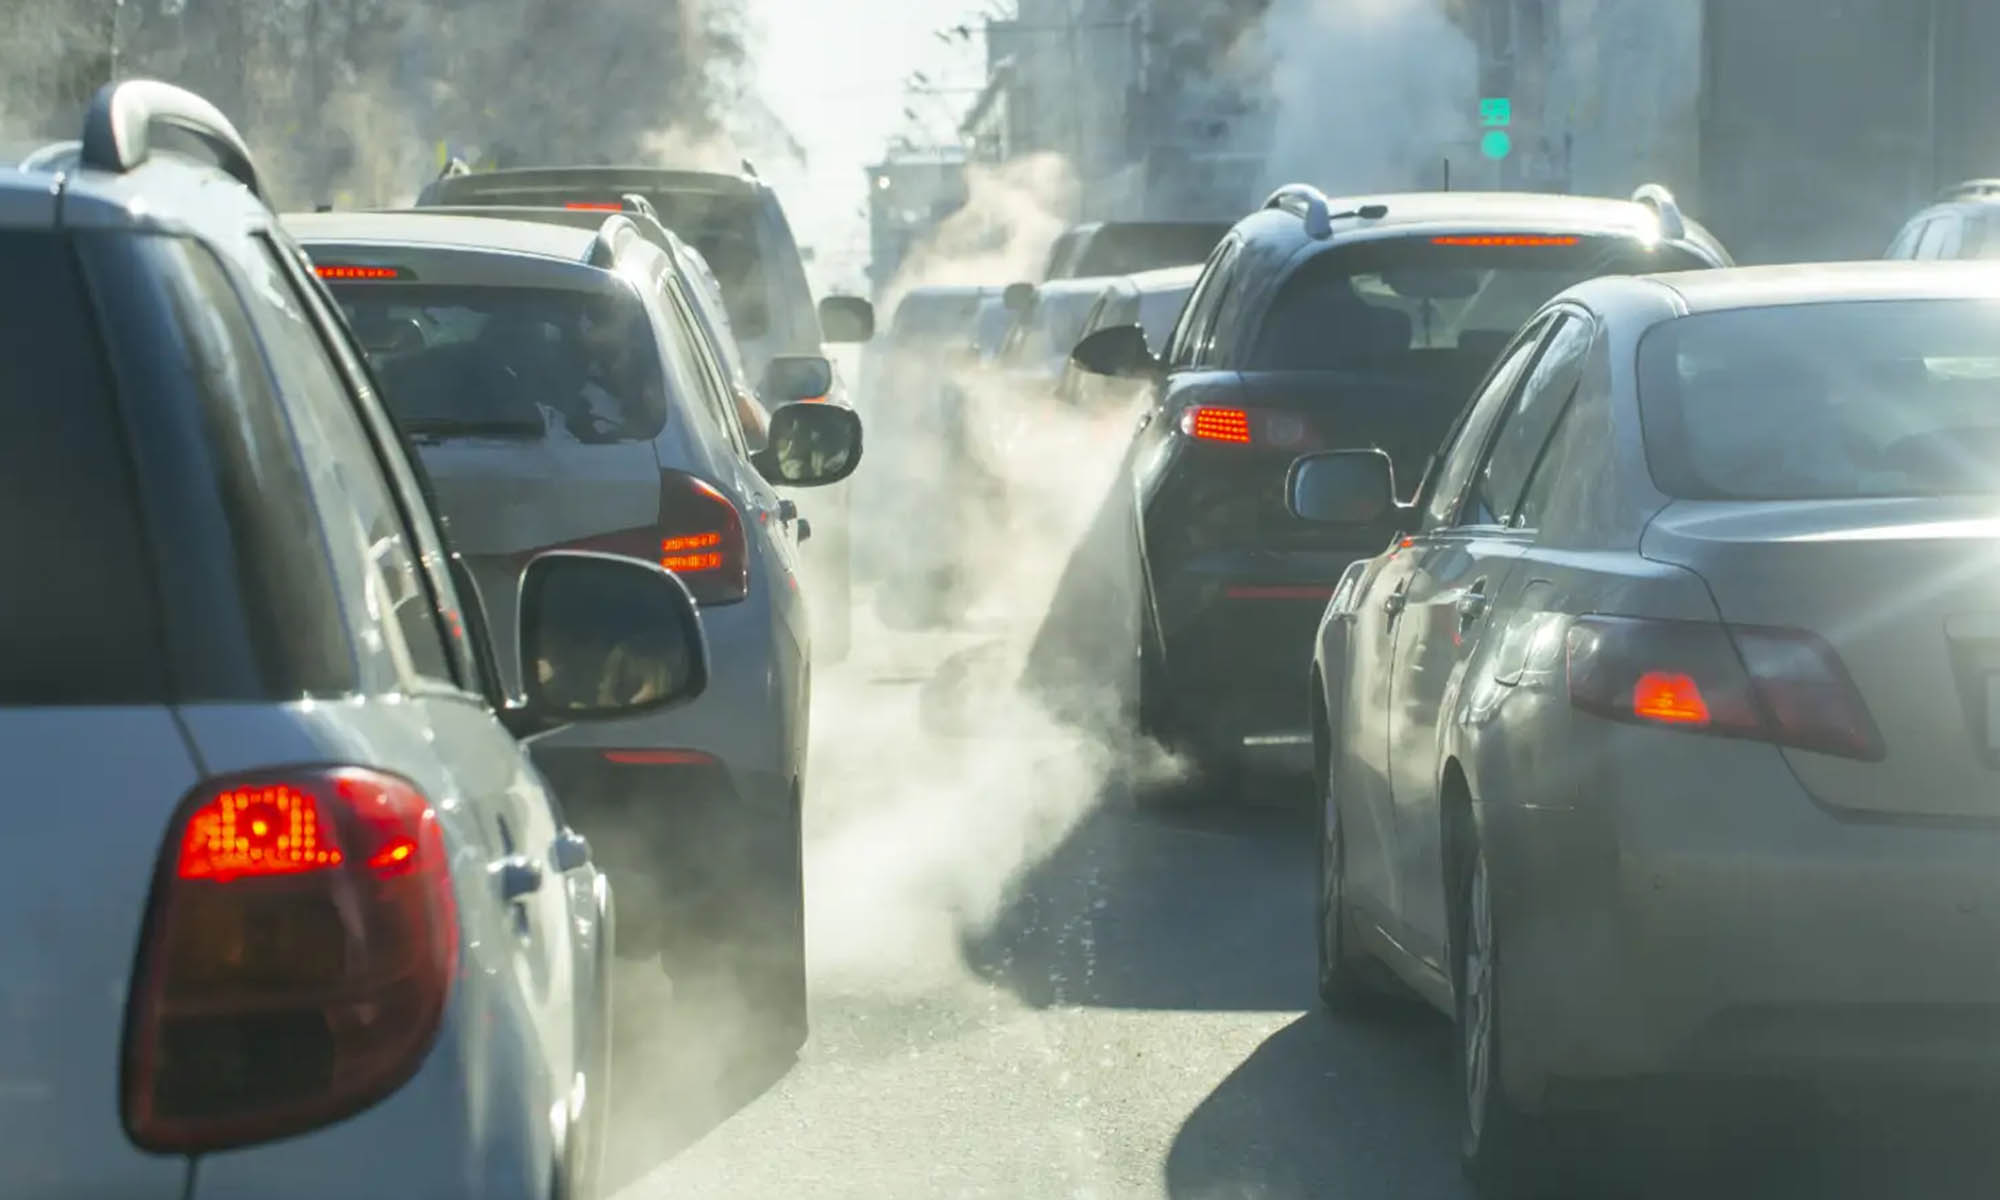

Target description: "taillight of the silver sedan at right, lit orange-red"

left=1568, top=616, right=1882, bottom=762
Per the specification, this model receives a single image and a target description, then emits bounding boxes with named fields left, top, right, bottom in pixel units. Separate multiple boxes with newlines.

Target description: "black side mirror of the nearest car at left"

left=510, top=550, right=708, bottom=732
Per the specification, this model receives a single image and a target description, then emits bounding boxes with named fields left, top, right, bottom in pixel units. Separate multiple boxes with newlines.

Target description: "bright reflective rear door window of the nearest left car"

left=246, top=240, right=458, bottom=688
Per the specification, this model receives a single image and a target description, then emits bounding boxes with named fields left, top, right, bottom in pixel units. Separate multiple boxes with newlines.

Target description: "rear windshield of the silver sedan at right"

left=1638, top=300, right=2000, bottom=500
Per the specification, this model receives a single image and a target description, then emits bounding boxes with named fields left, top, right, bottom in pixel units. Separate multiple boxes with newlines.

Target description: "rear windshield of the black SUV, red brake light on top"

left=1250, top=234, right=1708, bottom=368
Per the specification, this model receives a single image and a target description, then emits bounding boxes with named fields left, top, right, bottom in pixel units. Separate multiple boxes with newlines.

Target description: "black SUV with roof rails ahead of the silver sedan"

left=1074, top=184, right=1730, bottom=784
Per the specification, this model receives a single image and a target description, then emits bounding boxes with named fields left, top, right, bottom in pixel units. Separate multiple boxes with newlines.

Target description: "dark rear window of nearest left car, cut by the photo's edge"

left=0, top=232, right=166, bottom=704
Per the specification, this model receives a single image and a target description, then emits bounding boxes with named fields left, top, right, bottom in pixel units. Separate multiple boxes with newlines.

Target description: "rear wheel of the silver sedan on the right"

left=1452, top=820, right=1560, bottom=1200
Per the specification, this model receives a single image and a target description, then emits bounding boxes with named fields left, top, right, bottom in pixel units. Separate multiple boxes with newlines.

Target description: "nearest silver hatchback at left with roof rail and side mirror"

left=0, top=82, right=706, bottom=1200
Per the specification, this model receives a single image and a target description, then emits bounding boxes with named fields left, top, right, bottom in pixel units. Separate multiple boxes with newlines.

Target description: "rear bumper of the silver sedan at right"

left=1480, top=720, right=2000, bottom=1106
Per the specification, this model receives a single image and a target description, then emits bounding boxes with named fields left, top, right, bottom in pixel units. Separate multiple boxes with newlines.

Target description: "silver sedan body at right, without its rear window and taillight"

left=1310, top=264, right=2000, bottom=1110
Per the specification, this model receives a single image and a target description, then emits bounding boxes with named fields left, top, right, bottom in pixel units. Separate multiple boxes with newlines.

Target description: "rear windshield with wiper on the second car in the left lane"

left=334, top=284, right=666, bottom=442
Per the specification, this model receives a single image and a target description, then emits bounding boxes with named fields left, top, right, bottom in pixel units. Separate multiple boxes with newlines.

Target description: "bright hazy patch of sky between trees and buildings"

left=748, top=0, right=984, bottom=292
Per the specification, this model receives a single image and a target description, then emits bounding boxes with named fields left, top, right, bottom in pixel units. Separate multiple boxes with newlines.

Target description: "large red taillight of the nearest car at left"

left=124, top=768, right=458, bottom=1154
